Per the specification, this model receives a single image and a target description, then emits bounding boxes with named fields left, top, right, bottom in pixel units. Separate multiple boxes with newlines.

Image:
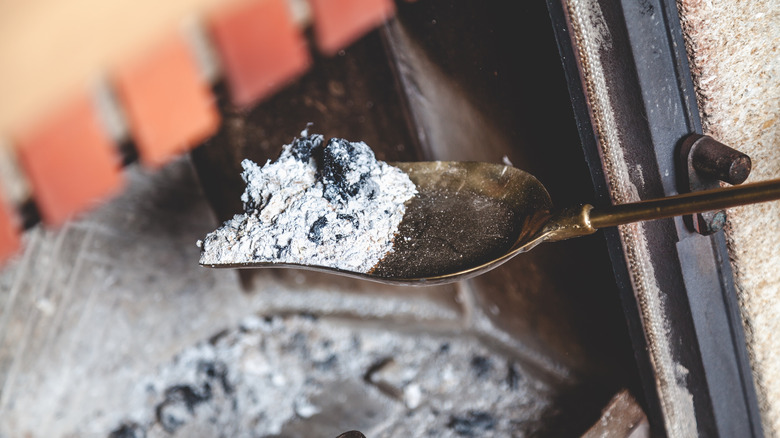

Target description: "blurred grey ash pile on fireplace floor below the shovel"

left=111, top=315, right=553, bottom=438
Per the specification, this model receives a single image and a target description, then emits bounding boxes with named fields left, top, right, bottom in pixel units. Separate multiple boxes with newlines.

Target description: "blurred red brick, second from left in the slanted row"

left=17, top=94, right=122, bottom=225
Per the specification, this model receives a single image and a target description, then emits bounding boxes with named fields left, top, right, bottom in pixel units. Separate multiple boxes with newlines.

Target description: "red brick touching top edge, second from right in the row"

left=210, top=0, right=311, bottom=106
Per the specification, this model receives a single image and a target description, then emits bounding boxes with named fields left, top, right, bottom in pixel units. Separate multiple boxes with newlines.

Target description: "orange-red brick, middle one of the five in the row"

left=114, top=34, right=219, bottom=167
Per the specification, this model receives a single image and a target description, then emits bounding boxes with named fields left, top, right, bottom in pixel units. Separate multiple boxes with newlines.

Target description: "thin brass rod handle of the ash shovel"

left=589, top=179, right=780, bottom=229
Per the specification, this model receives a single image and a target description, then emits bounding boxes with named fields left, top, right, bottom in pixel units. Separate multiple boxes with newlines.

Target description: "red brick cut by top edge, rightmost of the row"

left=309, top=0, right=395, bottom=55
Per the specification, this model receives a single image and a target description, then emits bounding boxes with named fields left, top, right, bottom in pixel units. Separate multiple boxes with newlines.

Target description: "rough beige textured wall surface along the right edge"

left=678, top=0, right=780, bottom=436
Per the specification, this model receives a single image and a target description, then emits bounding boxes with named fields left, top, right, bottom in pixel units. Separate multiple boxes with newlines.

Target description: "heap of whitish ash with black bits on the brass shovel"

left=199, top=130, right=417, bottom=273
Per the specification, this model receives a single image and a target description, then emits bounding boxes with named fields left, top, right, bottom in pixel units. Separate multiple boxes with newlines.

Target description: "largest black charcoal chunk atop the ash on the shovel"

left=322, top=138, right=376, bottom=202
